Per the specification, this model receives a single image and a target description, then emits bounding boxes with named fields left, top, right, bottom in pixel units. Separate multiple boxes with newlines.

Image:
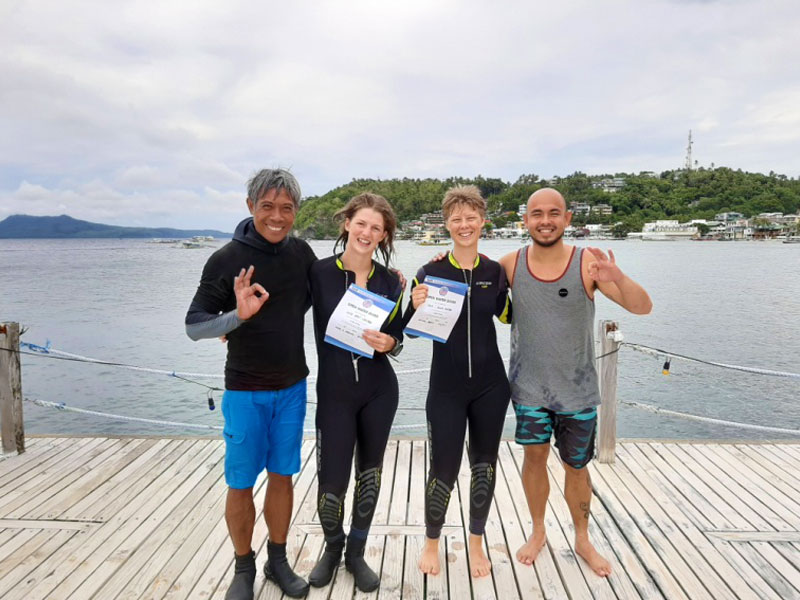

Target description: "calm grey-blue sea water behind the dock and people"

left=0, top=240, right=800, bottom=439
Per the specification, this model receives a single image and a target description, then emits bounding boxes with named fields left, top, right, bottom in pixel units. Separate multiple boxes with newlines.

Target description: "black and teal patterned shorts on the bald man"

left=514, top=402, right=597, bottom=469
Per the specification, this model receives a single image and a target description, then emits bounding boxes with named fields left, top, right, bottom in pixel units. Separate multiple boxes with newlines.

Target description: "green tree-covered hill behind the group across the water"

left=295, top=167, right=800, bottom=238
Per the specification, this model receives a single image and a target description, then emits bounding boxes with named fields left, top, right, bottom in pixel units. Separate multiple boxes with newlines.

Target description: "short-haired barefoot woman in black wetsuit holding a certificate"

left=403, top=185, right=511, bottom=577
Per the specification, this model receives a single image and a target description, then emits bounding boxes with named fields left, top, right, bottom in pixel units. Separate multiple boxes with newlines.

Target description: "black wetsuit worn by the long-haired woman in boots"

left=309, top=256, right=403, bottom=541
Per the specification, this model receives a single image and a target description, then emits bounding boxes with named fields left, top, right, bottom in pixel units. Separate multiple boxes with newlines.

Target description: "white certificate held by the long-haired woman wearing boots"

left=325, top=283, right=395, bottom=358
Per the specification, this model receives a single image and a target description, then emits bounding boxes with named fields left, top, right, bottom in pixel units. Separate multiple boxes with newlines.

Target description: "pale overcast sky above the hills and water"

left=0, top=0, right=800, bottom=231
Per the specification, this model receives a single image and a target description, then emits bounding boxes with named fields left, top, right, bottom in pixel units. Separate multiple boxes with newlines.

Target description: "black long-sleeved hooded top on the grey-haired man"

left=186, top=218, right=316, bottom=391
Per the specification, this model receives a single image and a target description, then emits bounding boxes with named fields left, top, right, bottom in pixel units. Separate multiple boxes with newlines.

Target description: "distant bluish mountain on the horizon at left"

left=0, top=215, right=231, bottom=239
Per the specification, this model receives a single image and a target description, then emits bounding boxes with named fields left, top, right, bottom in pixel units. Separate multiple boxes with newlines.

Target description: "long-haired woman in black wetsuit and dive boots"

left=309, top=193, right=403, bottom=592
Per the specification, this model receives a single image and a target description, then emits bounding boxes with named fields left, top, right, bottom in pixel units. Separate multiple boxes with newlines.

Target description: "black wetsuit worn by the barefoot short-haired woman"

left=403, top=253, right=511, bottom=538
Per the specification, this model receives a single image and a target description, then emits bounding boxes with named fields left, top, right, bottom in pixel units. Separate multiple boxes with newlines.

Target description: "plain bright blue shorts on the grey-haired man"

left=222, top=379, right=306, bottom=490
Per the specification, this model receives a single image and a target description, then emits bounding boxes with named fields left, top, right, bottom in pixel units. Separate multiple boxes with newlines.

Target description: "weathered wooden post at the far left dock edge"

left=0, top=323, right=25, bottom=454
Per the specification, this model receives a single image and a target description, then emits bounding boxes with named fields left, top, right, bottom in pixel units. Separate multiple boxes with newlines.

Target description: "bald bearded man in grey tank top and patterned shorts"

left=500, top=188, right=652, bottom=577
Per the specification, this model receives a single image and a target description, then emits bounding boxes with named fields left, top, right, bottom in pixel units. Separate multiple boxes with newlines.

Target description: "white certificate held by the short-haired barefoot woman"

left=405, top=277, right=469, bottom=344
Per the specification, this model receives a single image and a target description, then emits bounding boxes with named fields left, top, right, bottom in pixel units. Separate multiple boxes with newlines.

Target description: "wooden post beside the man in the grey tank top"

left=597, top=321, right=622, bottom=464
